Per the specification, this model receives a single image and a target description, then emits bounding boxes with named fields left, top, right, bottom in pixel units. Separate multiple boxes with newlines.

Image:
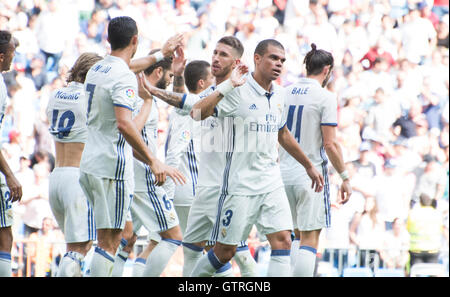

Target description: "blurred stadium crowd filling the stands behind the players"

left=0, top=0, right=449, bottom=276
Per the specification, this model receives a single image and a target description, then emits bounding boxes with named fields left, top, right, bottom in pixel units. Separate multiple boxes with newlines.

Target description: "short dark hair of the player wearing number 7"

left=108, top=16, right=138, bottom=50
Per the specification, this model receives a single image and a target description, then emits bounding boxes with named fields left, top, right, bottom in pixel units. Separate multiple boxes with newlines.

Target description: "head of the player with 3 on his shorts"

left=253, top=39, right=286, bottom=81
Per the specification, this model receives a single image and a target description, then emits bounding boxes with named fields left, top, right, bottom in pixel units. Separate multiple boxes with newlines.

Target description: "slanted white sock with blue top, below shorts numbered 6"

left=142, top=238, right=181, bottom=277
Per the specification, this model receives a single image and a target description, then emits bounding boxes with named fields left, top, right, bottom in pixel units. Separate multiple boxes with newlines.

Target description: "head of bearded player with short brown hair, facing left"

left=211, top=36, right=244, bottom=77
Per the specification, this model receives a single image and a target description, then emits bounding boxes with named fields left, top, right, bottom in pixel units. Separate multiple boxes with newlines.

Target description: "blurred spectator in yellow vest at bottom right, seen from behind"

left=407, top=194, right=444, bottom=266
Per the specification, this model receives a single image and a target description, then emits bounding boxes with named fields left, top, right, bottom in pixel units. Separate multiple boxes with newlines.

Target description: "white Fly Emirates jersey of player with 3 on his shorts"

left=214, top=74, right=285, bottom=196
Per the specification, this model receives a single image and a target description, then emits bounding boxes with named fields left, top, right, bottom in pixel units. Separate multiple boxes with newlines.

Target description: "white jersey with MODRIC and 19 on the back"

left=46, top=81, right=87, bottom=143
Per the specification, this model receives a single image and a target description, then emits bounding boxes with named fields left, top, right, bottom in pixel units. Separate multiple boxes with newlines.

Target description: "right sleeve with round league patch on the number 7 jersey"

left=111, top=72, right=138, bottom=111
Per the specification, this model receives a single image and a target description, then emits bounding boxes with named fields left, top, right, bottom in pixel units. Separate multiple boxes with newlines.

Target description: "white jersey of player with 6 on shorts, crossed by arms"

left=133, top=98, right=159, bottom=193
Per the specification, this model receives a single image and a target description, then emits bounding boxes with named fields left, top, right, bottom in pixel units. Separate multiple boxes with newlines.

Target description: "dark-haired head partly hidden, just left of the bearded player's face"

left=184, top=60, right=214, bottom=94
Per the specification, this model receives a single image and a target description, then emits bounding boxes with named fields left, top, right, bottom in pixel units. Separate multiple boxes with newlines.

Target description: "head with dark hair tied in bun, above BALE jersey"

left=303, top=43, right=334, bottom=87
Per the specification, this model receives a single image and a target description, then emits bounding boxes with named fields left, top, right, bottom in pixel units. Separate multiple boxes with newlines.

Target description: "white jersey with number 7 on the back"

left=80, top=56, right=138, bottom=180
